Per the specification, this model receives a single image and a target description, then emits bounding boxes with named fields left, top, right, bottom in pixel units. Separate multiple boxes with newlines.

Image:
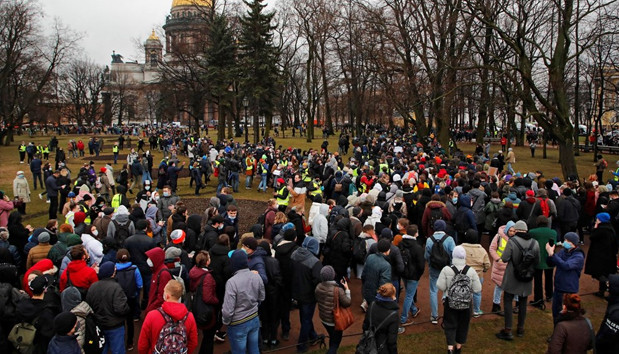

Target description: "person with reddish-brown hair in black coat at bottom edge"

left=363, top=283, right=399, bottom=354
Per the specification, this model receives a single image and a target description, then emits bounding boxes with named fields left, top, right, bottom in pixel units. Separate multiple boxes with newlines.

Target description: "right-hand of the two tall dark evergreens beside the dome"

left=239, top=0, right=279, bottom=144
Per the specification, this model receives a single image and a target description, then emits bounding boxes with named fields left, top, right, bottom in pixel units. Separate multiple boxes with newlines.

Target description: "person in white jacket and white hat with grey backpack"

left=436, top=246, right=487, bottom=354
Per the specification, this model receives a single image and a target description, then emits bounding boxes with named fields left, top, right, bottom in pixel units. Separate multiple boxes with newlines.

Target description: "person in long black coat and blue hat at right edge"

left=585, top=213, right=618, bottom=298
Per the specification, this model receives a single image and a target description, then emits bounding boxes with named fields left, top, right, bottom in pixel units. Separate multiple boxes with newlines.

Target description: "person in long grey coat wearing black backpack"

left=496, top=220, right=539, bottom=340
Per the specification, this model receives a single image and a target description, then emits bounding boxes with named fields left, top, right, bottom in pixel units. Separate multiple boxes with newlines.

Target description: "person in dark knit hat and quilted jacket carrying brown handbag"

left=315, top=265, right=352, bottom=354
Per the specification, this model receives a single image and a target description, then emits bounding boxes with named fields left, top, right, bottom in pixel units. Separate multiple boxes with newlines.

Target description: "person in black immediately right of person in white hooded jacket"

left=324, top=218, right=352, bottom=282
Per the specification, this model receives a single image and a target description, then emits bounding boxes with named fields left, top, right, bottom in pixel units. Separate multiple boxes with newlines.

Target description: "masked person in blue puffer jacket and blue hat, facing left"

left=546, top=232, right=585, bottom=324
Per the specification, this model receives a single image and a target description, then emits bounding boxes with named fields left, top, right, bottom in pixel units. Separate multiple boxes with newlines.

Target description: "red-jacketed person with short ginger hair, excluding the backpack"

left=138, top=280, right=198, bottom=354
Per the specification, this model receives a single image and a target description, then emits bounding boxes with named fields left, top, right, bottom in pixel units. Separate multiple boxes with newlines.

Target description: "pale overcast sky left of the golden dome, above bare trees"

left=39, top=0, right=172, bottom=65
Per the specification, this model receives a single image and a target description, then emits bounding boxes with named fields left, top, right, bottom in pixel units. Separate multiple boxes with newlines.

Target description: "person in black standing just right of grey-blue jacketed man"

left=258, top=241, right=284, bottom=348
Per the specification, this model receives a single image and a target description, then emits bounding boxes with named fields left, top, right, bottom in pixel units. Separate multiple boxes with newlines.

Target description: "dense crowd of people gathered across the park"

left=0, top=131, right=619, bottom=353
